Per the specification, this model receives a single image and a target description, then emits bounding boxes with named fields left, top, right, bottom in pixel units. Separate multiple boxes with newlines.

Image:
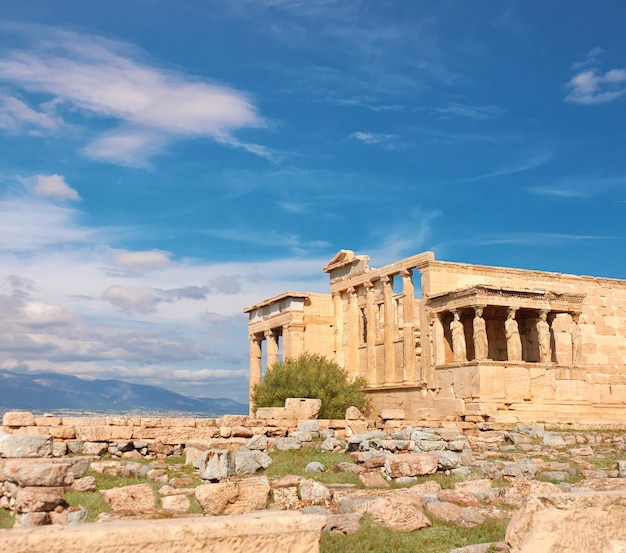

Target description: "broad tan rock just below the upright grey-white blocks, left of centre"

left=194, top=476, right=270, bottom=515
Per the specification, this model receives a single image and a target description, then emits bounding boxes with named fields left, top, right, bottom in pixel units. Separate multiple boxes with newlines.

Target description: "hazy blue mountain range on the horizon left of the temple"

left=0, top=370, right=248, bottom=416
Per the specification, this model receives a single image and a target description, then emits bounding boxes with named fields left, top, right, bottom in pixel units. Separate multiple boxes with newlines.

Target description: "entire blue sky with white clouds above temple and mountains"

left=0, top=0, right=626, bottom=401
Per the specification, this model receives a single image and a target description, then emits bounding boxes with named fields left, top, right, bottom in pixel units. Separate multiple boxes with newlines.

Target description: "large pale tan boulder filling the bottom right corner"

left=506, top=491, right=626, bottom=553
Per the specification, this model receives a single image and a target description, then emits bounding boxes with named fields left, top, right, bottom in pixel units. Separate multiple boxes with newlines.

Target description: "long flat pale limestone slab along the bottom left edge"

left=0, top=511, right=326, bottom=553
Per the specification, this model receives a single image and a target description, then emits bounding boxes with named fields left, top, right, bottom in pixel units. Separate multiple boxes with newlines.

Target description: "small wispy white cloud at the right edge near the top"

left=565, top=47, right=626, bottom=105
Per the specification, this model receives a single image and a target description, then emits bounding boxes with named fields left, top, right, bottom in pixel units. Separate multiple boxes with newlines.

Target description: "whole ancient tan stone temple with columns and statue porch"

left=245, top=250, right=626, bottom=424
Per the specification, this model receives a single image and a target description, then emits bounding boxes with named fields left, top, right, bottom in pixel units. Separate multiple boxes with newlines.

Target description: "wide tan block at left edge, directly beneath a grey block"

left=0, top=459, right=74, bottom=486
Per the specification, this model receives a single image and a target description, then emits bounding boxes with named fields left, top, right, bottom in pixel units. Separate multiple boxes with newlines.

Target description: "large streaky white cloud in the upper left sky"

left=0, top=25, right=267, bottom=165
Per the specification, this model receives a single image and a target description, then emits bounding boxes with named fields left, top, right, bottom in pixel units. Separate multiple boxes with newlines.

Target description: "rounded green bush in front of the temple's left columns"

left=252, top=352, right=369, bottom=419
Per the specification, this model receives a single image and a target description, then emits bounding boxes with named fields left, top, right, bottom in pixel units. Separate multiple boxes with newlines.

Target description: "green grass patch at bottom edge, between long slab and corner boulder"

left=320, top=515, right=509, bottom=553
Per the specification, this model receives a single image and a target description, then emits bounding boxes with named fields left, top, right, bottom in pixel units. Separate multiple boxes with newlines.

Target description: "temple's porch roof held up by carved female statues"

left=426, top=286, right=585, bottom=367
